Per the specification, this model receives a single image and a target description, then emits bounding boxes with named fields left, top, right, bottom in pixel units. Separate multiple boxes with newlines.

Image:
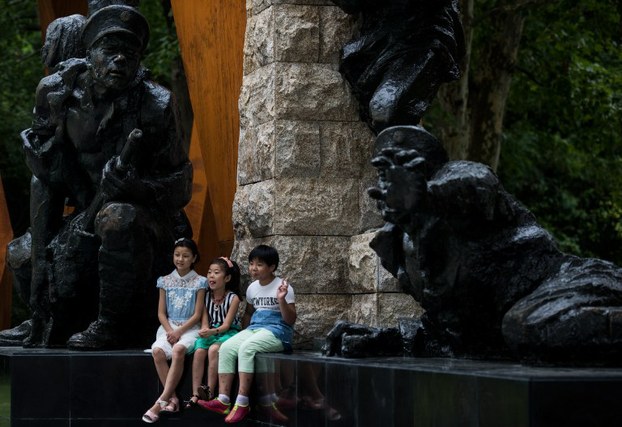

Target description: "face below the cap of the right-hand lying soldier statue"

left=368, top=148, right=426, bottom=224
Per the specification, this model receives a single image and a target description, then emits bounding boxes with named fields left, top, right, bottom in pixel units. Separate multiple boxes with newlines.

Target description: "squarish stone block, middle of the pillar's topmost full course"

left=274, top=4, right=320, bottom=62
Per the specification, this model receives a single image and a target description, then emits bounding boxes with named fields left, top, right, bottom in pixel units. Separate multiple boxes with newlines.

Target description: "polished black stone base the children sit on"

left=0, top=348, right=622, bottom=427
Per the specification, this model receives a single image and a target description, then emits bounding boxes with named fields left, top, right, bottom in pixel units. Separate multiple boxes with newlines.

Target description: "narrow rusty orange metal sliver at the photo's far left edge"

left=0, top=178, right=13, bottom=330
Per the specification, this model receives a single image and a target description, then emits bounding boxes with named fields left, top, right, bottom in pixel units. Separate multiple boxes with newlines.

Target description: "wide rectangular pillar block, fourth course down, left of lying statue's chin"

left=274, top=178, right=359, bottom=236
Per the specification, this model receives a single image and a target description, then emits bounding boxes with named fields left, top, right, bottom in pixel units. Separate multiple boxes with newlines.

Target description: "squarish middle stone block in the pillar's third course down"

left=276, top=121, right=321, bottom=178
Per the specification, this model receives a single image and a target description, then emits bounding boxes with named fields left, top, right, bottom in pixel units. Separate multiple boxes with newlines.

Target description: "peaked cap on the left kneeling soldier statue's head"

left=82, top=5, right=149, bottom=50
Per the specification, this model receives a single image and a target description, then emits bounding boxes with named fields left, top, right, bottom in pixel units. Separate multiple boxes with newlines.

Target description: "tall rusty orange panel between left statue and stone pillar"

left=171, top=0, right=246, bottom=256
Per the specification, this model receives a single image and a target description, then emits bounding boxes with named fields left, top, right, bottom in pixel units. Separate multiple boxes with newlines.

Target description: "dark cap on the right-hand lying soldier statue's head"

left=374, top=126, right=449, bottom=178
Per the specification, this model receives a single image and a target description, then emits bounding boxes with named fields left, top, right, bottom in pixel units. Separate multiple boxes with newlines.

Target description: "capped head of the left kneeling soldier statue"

left=82, top=5, right=149, bottom=91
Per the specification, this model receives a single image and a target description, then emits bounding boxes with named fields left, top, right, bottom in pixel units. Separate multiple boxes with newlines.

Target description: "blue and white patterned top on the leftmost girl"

left=157, top=270, right=207, bottom=323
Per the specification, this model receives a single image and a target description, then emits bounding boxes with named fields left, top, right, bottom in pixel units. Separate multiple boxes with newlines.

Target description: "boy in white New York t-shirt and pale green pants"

left=199, top=245, right=296, bottom=423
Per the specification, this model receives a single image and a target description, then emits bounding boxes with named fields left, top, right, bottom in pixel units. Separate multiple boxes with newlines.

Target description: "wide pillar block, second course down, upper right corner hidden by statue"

left=276, top=63, right=358, bottom=121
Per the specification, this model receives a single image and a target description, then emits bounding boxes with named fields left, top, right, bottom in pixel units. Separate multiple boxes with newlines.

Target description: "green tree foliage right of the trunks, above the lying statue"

left=498, top=0, right=622, bottom=265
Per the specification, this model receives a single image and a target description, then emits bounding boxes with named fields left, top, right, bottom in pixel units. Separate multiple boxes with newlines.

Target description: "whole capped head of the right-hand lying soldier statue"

left=368, top=126, right=448, bottom=224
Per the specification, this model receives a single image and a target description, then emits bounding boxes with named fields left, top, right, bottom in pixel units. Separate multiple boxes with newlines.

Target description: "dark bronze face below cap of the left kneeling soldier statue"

left=88, top=33, right=141, bottom=91
